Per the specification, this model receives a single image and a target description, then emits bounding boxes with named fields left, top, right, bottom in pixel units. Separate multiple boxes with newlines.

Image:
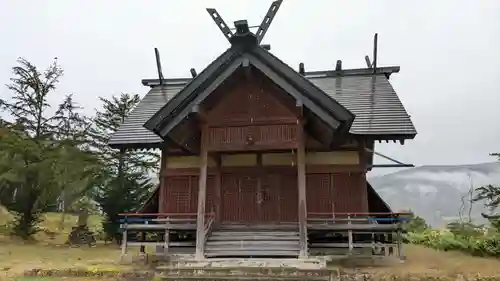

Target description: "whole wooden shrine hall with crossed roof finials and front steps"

left=109, top=1, right=416, bottom=259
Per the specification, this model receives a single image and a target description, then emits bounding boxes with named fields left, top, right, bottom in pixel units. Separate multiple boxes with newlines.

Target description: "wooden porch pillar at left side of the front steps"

left=196, top=124, right=208, bottom=260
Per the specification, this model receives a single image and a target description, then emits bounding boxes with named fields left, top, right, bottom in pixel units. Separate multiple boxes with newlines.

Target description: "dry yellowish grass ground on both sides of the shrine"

left=0, top=206, right=500, bottom=281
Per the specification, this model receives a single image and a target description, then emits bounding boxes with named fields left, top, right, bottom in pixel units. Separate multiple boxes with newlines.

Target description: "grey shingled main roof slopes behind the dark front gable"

left=109, top=69, right=417, bottom=146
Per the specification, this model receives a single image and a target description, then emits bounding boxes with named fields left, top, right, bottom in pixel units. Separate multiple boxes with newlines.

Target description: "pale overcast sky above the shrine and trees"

left=0, top=0, right=500, bottom=175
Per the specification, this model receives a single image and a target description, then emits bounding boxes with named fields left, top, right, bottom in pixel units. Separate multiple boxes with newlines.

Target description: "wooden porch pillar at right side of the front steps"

left=297, top=122, right=307, bottom=258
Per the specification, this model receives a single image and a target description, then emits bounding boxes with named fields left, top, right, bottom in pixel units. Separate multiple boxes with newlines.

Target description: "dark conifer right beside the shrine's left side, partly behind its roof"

left=92, top=94, right=159, bottom=239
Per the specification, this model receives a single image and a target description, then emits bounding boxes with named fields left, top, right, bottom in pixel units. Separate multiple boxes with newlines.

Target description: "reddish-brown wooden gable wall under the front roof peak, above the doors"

left=206, top=67, right=298, bottom=151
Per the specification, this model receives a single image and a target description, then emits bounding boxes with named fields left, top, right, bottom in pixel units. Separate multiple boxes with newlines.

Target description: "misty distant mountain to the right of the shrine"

left=368, top=162, right=500, bottom=227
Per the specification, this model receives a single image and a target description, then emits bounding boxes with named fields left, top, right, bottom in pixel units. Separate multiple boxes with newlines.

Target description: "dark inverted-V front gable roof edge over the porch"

left=144, top=32, right=354, bottom=137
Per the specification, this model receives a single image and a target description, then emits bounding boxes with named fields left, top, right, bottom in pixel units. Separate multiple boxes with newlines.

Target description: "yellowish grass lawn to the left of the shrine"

left=0, top=206, right=131, bottom=281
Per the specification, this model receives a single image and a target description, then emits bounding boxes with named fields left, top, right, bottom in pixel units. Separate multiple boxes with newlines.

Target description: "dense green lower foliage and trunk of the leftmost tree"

left=0, top=124, right=61, bottom=236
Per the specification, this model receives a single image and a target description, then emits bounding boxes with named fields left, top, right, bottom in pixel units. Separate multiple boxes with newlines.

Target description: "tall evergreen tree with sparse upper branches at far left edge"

left=0, top=58, right=96, bottom=239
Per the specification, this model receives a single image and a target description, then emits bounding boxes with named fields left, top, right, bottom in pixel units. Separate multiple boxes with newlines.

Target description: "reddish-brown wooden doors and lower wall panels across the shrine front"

left=164, top=168, right=368, bottom=220
